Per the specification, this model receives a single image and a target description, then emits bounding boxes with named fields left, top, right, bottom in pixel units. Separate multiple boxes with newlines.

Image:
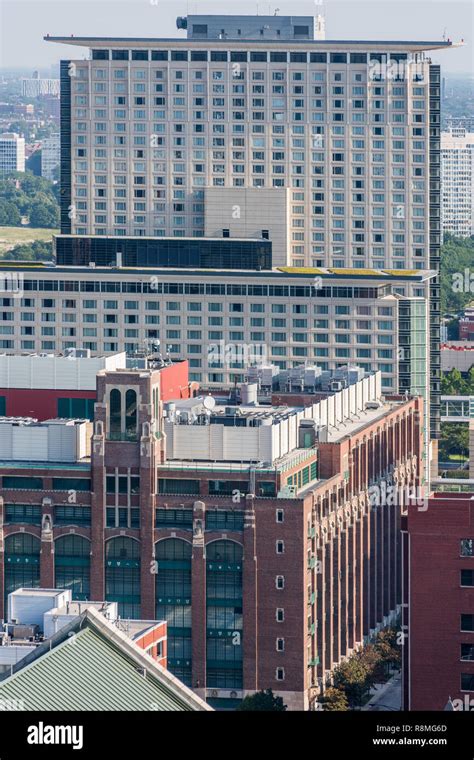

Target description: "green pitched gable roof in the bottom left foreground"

left=0, top=612, right=210, bottom=711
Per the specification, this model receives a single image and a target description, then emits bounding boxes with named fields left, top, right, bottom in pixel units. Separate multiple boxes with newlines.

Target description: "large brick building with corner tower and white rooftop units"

left=0, top=370, right=423, bottom=709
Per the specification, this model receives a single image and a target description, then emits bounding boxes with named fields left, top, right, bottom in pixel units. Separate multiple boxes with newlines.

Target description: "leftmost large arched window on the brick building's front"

left=4, top=533, right=41, bottom=617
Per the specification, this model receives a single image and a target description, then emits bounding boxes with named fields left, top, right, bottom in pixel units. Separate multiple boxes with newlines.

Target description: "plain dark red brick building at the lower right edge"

left=403, top=493, right=474, bottom=710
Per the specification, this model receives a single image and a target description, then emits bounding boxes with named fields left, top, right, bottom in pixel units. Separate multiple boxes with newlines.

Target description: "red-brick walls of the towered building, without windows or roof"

left=0, top=371, right=423, bottom=709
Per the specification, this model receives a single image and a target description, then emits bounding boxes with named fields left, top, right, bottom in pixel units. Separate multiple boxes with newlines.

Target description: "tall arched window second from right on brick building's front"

left=155, top=538, right=192, bottom=686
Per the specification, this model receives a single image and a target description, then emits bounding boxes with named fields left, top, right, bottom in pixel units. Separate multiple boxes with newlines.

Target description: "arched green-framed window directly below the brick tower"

left=105, top=536, right=141, bottom=619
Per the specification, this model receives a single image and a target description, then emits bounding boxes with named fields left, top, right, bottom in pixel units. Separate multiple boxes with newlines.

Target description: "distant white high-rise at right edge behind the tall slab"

left=441, top=127, right=474, bottom=237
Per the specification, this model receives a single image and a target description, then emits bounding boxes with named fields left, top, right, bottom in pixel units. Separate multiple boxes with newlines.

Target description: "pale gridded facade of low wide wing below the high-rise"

left=0, top=267, right=431, bottom=392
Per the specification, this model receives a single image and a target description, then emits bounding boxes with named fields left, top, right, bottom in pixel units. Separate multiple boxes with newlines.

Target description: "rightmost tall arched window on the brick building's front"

left=206, top=541, right=243, bottom=689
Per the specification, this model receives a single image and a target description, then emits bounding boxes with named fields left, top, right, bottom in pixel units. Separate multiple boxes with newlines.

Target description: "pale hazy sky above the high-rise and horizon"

left=0, top=0, right=474, bottom=74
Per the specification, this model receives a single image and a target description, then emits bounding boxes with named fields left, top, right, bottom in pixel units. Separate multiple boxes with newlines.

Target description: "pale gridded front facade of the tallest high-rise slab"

left=52, top=38, right=444, bottom=269
